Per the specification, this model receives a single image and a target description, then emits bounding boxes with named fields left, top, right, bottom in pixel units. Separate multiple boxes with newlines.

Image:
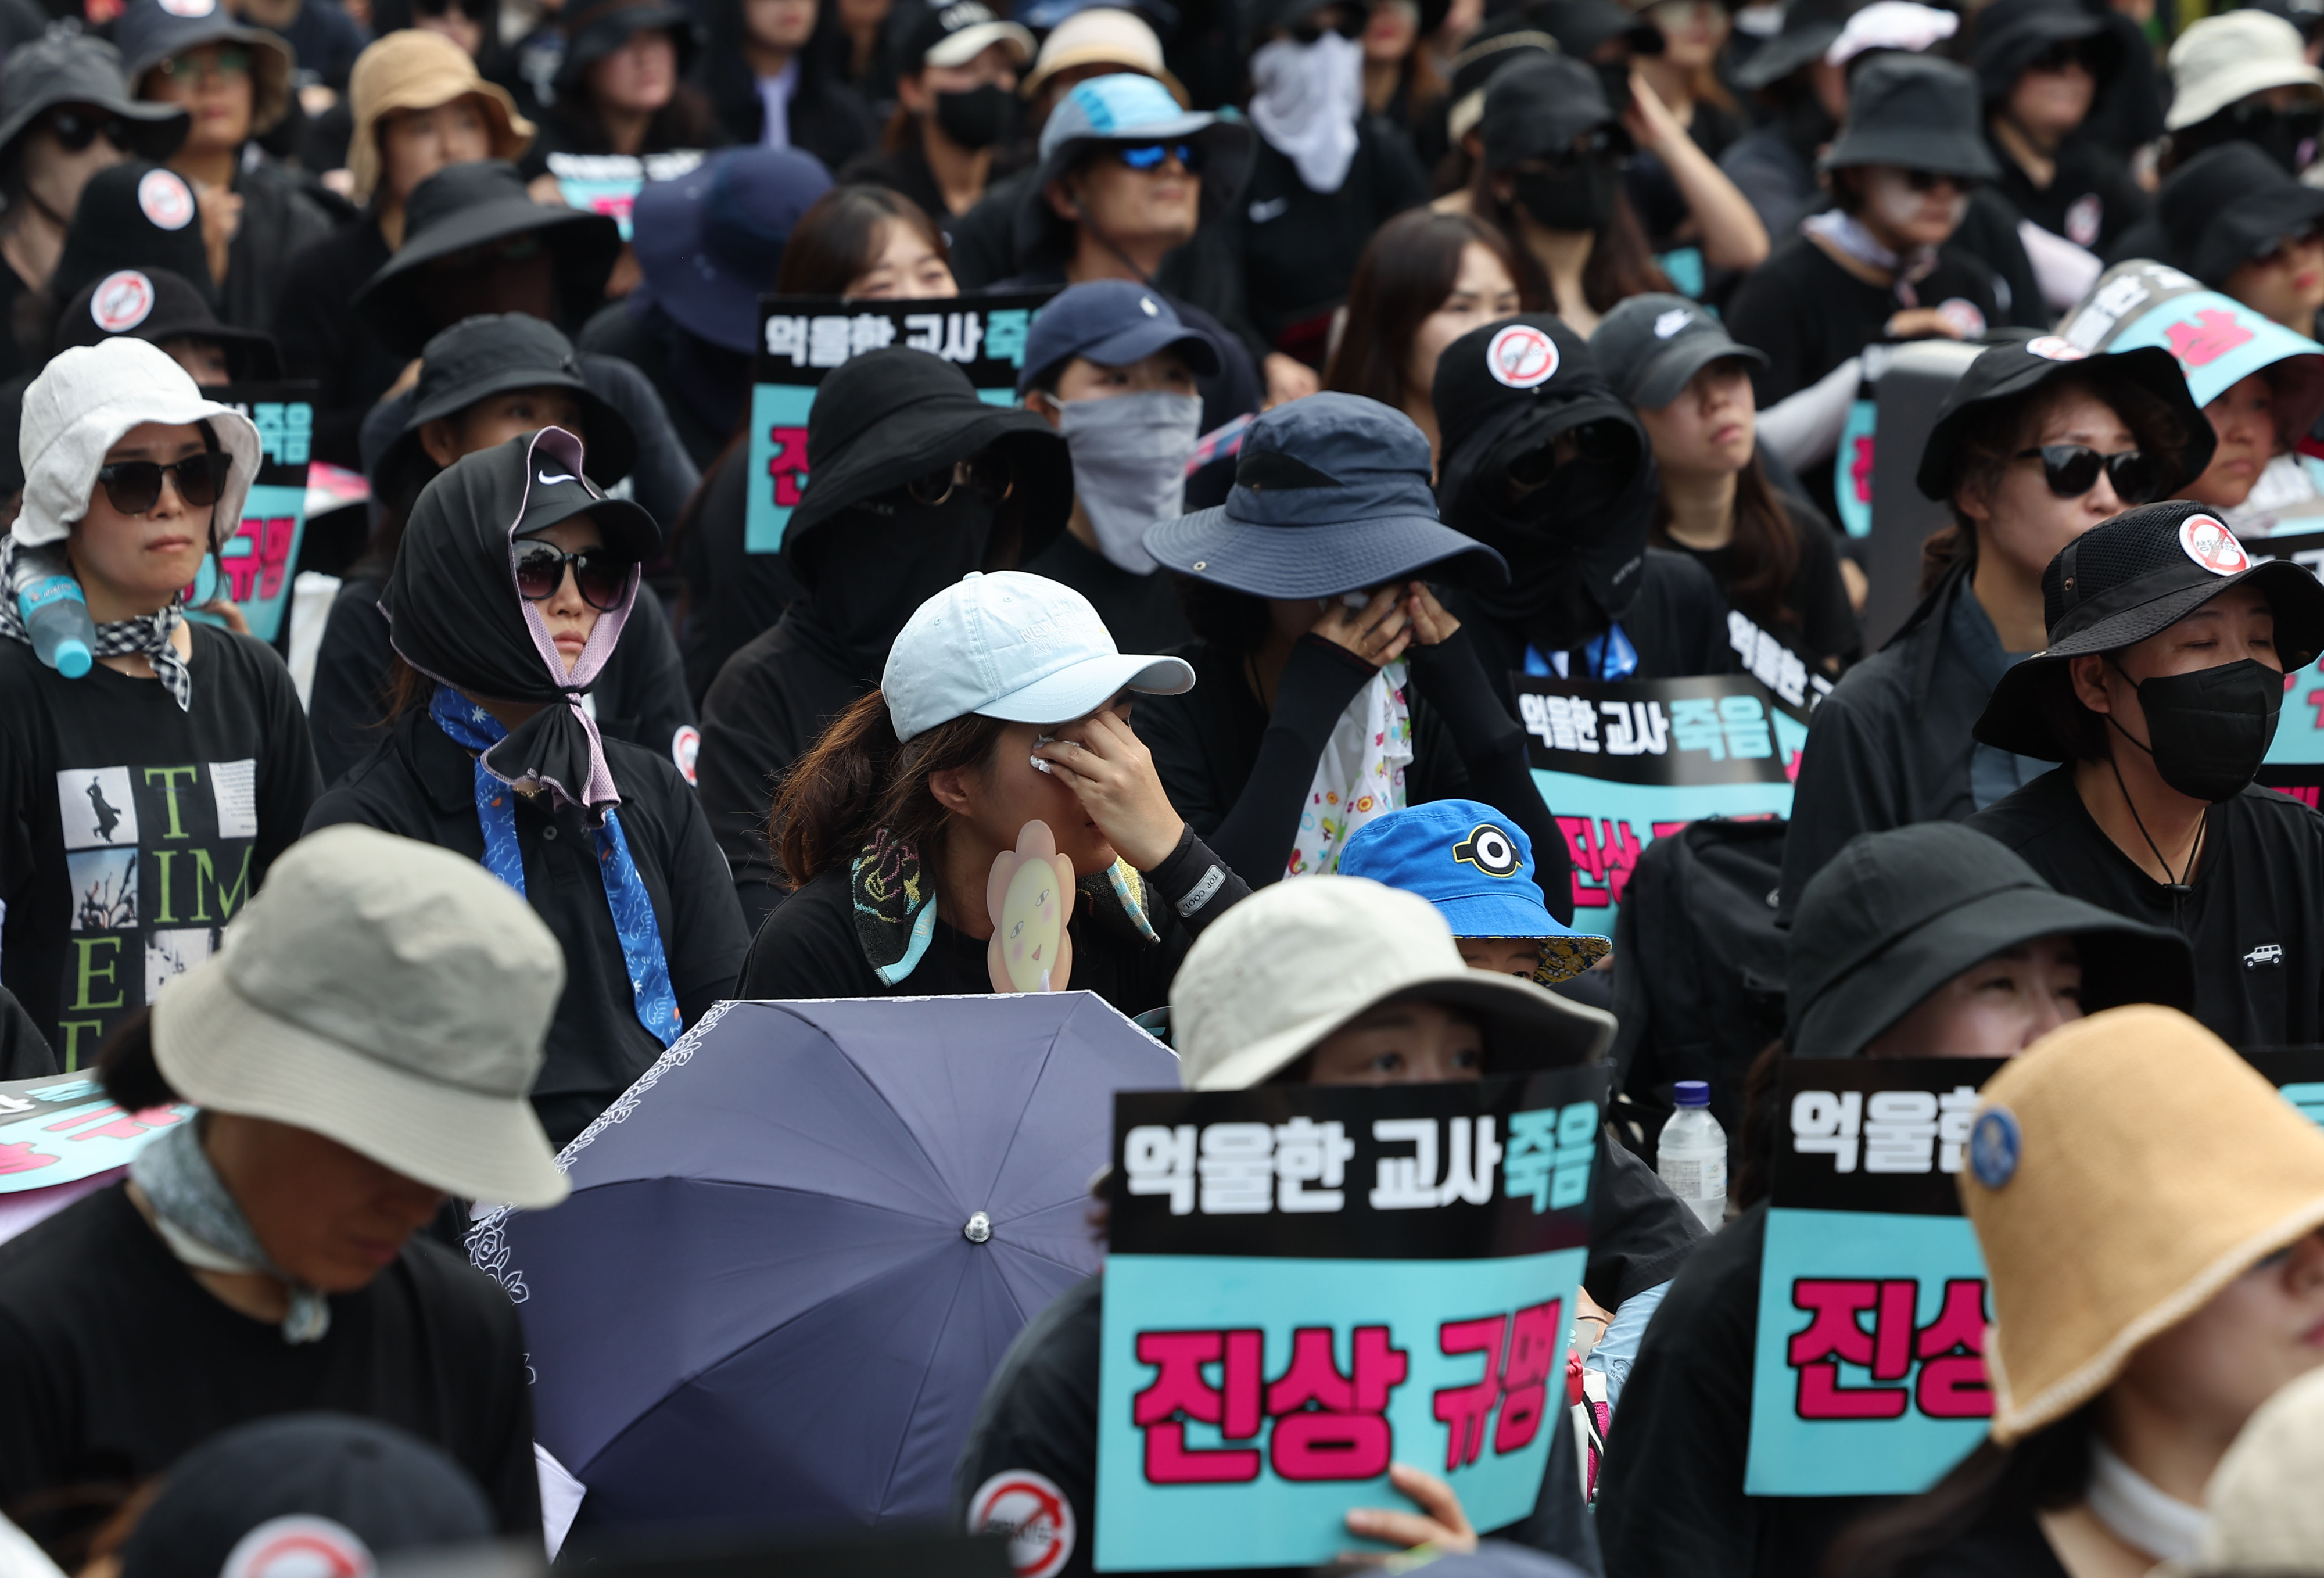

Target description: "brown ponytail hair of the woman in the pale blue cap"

left=767, top=690, right=1009, bottom=888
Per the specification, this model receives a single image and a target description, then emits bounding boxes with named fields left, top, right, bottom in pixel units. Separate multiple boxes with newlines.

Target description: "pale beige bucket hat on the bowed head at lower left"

left=153, top=827, right=565, bottom=1208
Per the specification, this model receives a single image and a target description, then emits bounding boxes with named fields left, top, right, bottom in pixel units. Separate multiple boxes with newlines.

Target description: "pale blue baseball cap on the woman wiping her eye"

left=878, top=569, right=1195, bottom=741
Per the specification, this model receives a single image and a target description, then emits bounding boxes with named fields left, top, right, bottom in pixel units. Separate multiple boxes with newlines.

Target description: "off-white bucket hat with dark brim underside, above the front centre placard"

left=1169, top=876, right=1613, bottom=1090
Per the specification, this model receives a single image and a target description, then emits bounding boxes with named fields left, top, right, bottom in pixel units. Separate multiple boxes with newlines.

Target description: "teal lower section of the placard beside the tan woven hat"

left=1743, top=1206, right=1992, bottom=1497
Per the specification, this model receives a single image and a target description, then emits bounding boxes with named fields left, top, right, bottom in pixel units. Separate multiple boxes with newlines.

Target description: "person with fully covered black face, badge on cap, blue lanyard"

left=1436, top=314, right=1734, bottom=702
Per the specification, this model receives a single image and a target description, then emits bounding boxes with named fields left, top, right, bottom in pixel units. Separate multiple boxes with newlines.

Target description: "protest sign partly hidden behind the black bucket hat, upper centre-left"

left=744, top=291, right=1055, bottom=553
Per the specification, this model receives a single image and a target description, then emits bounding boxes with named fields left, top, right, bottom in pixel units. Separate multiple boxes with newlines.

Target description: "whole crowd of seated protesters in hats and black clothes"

left=0, top=0, right=2324, bottom=1578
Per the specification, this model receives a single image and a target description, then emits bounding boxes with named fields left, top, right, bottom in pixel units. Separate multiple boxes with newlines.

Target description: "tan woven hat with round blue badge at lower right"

left=1971, top=1013, right=2324, bottom=1446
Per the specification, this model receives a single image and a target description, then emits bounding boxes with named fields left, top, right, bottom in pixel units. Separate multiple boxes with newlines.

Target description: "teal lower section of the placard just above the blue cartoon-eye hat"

left=1534, top=706, right=1808, bottom=937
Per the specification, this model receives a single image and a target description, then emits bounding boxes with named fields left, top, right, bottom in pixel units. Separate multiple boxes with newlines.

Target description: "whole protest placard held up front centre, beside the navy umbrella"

left=1095, top=1067, right=1606, bottom=1571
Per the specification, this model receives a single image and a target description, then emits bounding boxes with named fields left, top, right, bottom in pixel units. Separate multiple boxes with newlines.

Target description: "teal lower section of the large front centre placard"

left=1095, top=1248, right=1585, bottom=1571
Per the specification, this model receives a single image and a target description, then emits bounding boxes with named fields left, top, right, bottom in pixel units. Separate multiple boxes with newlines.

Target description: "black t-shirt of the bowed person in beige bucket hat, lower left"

left=0, top=1183, right=541, bottom=1541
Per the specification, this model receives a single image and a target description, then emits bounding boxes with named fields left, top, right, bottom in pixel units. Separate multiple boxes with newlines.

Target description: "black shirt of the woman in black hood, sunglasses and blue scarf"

left=307, top=711, right=751, bottom=1146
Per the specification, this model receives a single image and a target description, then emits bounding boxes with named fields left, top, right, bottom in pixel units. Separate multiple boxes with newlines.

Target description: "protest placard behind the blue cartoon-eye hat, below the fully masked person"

left=1511, top=669, right=1831, bottom=937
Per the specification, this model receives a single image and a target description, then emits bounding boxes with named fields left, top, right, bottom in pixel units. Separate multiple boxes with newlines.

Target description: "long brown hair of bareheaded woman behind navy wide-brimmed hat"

left=1322, top=209, right=1545, bottom=411
